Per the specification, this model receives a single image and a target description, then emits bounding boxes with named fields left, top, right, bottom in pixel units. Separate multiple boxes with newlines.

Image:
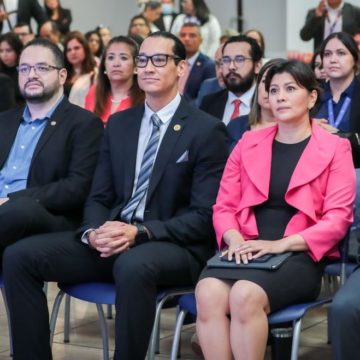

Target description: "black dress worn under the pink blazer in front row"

left=200, top=138, right=324, bottom=311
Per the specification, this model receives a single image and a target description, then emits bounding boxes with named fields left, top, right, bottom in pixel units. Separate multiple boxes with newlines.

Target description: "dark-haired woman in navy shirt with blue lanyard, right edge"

left=311, top=32, right=360, bottom=168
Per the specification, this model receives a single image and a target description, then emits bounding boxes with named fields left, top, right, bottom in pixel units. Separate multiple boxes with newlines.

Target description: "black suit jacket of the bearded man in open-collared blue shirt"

left=0, top=98, right=103, bottom=221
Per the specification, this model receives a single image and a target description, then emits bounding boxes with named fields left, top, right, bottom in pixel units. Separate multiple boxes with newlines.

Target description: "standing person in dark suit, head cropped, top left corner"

left=0, top=0, right=46, bottom=33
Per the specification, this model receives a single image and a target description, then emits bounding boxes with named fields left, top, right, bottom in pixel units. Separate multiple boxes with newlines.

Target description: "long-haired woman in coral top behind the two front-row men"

left=85, top=36, right=144, bottom=124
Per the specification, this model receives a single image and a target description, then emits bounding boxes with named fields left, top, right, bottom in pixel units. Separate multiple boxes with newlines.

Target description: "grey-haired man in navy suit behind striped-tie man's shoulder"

left=179, top=23, right=216, bottom=103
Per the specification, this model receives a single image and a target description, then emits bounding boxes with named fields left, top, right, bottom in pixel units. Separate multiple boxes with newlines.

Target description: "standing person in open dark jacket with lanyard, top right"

left=300, top=0, right=360, bottom=50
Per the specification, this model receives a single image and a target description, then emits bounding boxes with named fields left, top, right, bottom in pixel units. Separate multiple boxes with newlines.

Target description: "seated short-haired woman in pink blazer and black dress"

left=196, top=60, right=355, bottom=360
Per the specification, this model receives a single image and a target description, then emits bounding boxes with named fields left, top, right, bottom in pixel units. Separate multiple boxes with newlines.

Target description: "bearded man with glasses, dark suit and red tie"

left=200, top=35, right=262, bottom=125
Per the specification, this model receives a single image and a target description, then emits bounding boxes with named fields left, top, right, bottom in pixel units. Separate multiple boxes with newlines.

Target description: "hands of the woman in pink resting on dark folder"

left=224, top=230, right=284, bottom=264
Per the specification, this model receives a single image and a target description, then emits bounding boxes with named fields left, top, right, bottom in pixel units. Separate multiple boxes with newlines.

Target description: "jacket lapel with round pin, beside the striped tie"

left=146, top=99, right=189, bottom=202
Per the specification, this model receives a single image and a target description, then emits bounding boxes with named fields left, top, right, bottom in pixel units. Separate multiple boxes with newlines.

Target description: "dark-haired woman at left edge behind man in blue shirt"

left=0, top=32, right=24, bottom=104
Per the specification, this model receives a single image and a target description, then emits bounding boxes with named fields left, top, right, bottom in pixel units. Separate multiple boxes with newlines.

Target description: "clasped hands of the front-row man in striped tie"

left=89, top=221, right=138, bottom=258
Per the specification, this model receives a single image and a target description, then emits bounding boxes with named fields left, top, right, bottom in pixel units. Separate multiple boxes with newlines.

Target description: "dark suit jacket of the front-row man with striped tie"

left=79, top=99, right=228, bottom=278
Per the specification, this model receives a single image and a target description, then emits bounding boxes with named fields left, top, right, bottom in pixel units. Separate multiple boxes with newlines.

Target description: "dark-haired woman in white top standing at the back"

left=171, top=0, right=221, bottom=59
